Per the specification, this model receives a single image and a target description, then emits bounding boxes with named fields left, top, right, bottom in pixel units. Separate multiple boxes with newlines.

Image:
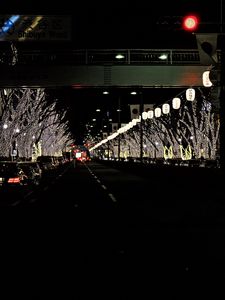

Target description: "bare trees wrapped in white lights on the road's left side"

left=0, top=88, right=72, bottom=158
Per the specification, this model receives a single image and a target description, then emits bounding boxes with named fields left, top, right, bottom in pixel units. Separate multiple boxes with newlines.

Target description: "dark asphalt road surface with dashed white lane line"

left=0, top=161, right=225, bottom=299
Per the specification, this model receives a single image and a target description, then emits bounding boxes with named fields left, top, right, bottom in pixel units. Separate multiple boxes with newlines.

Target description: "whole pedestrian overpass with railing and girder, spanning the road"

left=0, top=49, right=220, bottom=88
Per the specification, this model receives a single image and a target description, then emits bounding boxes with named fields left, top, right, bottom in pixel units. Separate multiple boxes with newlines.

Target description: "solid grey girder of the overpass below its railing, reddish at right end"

left=0, top=65, right=209, bottom=88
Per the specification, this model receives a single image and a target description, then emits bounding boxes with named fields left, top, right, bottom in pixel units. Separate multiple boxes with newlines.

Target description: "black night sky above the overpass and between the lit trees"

left=1, top=0, right=225, bottom=143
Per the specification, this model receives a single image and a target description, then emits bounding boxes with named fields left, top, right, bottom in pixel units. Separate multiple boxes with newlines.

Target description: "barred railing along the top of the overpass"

left=11, top=49, right=206, bottom=65
